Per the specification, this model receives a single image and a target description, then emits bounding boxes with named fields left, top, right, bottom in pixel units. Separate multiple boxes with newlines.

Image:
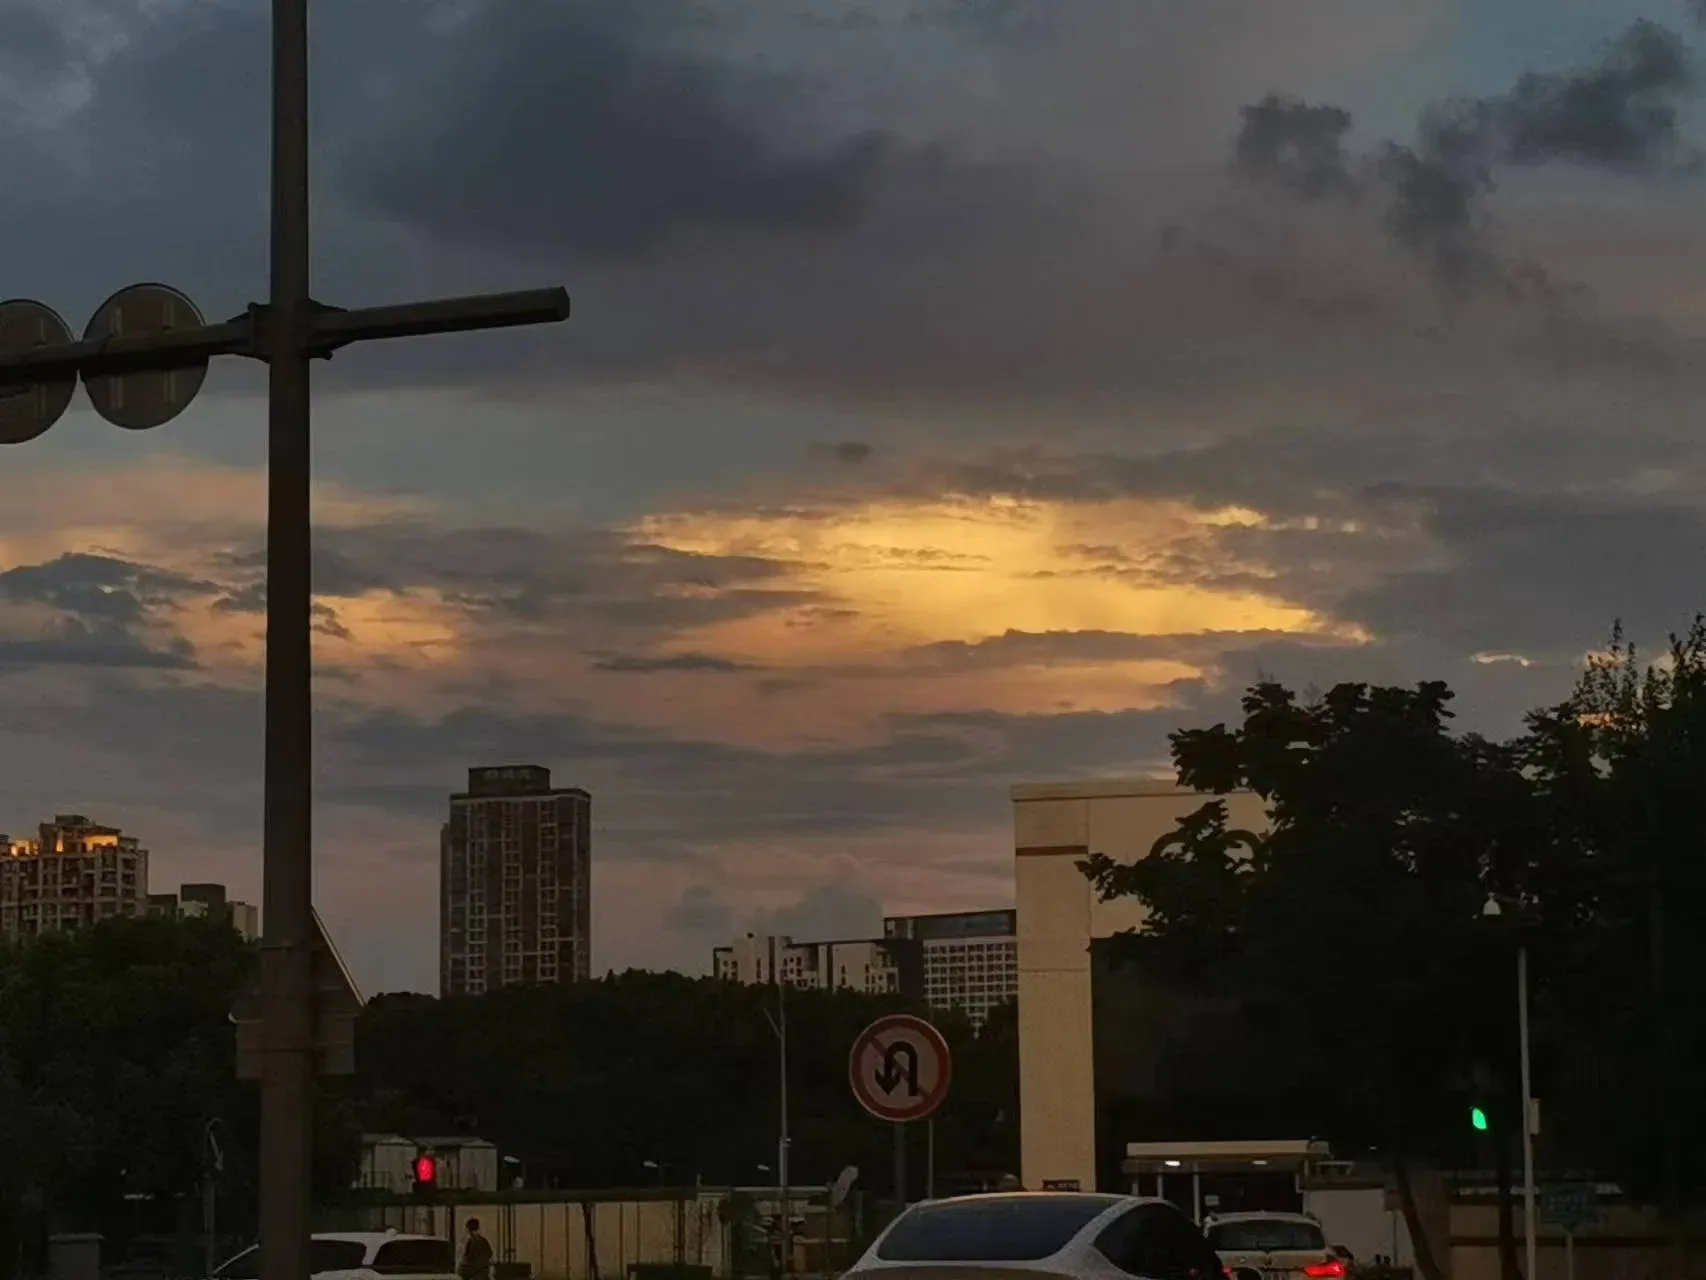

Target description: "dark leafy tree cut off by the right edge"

left=1525, top=618, right=1706, bottom=1256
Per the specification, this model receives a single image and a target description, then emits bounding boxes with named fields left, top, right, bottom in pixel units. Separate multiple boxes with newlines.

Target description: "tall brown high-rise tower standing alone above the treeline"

left=438, top=765, right=592, bottom=997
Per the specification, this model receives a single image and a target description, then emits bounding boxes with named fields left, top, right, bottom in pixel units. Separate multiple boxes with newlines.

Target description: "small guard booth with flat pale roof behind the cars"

left=1119, top=1140, right=1334, bottom=1222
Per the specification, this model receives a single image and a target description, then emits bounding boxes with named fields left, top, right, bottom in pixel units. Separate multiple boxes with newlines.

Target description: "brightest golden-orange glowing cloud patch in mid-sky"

left=635, top=500, right=1338, bottom=674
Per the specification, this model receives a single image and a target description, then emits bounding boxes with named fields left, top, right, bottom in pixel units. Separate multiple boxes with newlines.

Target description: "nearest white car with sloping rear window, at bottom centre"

left=843, top=1191, right=1225, bottom=1280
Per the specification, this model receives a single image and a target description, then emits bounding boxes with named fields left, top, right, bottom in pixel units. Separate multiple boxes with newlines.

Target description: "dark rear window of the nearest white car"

left=877, top=1195, right=1114, bottom=1263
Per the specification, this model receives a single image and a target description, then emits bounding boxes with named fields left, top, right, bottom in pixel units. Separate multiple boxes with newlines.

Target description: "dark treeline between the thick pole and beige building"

left=355, top=973, right=1018, bottom=1190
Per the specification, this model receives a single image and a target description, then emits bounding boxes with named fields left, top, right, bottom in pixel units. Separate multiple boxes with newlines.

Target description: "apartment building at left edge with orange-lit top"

left=0, top=814, right=148, bottom=940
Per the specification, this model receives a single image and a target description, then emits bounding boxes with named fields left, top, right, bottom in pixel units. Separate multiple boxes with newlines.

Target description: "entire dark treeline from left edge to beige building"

left=0, top=918, right=1018, bottom=1275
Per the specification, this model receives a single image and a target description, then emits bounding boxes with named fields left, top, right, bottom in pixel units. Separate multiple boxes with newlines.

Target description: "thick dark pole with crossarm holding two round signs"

left=0, top=0, right=568, bottom=1280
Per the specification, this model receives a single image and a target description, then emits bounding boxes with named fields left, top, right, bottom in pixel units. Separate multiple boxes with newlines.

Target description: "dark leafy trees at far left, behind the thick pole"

left=0, top=918, right=358, bottom=1263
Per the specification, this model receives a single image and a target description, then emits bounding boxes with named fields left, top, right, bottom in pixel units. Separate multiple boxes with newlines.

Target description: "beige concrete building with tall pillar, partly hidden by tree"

left=1012, top=780, right=1266, bottom=1190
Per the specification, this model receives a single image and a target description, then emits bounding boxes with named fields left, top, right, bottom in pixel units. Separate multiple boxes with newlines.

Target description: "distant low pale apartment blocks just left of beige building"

left=711, top=910, right=1018, bottom=1026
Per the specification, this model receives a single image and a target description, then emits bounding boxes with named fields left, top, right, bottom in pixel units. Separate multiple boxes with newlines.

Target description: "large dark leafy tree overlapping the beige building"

left=1083, top=683, right=1549, bottom=1280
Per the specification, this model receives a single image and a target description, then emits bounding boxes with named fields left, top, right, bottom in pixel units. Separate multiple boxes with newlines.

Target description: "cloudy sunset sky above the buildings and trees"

left=0, top=0, right=1706, bottom=992
